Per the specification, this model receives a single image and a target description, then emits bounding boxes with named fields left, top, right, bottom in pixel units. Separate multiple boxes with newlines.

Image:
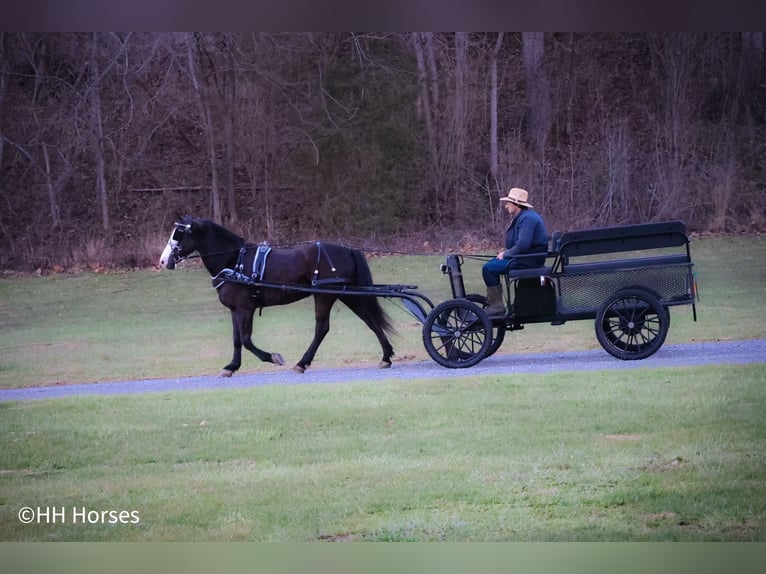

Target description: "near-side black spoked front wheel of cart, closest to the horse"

left=423, top=299, right=492, bottom=369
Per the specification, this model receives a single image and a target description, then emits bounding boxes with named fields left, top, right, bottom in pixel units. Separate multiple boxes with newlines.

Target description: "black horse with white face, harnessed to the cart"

left=160, top=216, right=394, bottom=377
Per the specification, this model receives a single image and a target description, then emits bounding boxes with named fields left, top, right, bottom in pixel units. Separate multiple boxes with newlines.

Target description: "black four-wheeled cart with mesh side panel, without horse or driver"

left=423, top=221, right=697, bottom=368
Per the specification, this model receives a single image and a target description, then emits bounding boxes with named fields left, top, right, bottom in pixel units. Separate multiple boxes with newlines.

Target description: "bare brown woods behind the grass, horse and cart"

left=0, top=32, right=766, bottom=268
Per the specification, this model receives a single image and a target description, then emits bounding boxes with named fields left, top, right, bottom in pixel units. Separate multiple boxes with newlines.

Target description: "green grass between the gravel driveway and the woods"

left=0, top=237, right=766, bottom=388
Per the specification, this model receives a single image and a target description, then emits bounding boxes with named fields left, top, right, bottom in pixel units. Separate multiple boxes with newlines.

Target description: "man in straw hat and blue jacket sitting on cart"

left=481, top=187, right=548, bottom=317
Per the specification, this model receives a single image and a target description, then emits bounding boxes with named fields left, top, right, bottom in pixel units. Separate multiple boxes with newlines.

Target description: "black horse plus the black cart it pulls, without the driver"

left=160, top=218, right=697, bottom=375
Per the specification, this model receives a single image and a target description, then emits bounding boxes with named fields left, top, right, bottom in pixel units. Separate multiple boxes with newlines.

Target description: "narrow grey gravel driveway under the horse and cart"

left=0, top=339, right=766, bottom=401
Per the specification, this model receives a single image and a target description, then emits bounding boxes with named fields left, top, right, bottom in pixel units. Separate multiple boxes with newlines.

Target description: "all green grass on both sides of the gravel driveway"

left=0, top=237, right=766, bottom=542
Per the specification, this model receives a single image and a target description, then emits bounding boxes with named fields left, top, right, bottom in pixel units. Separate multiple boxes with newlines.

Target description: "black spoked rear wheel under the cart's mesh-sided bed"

left=596, top=288, right=670, bottom=361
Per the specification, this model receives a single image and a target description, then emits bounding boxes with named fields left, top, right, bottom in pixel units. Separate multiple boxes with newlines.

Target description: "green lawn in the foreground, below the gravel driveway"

left=0, top=365, right=766, bottom=541
